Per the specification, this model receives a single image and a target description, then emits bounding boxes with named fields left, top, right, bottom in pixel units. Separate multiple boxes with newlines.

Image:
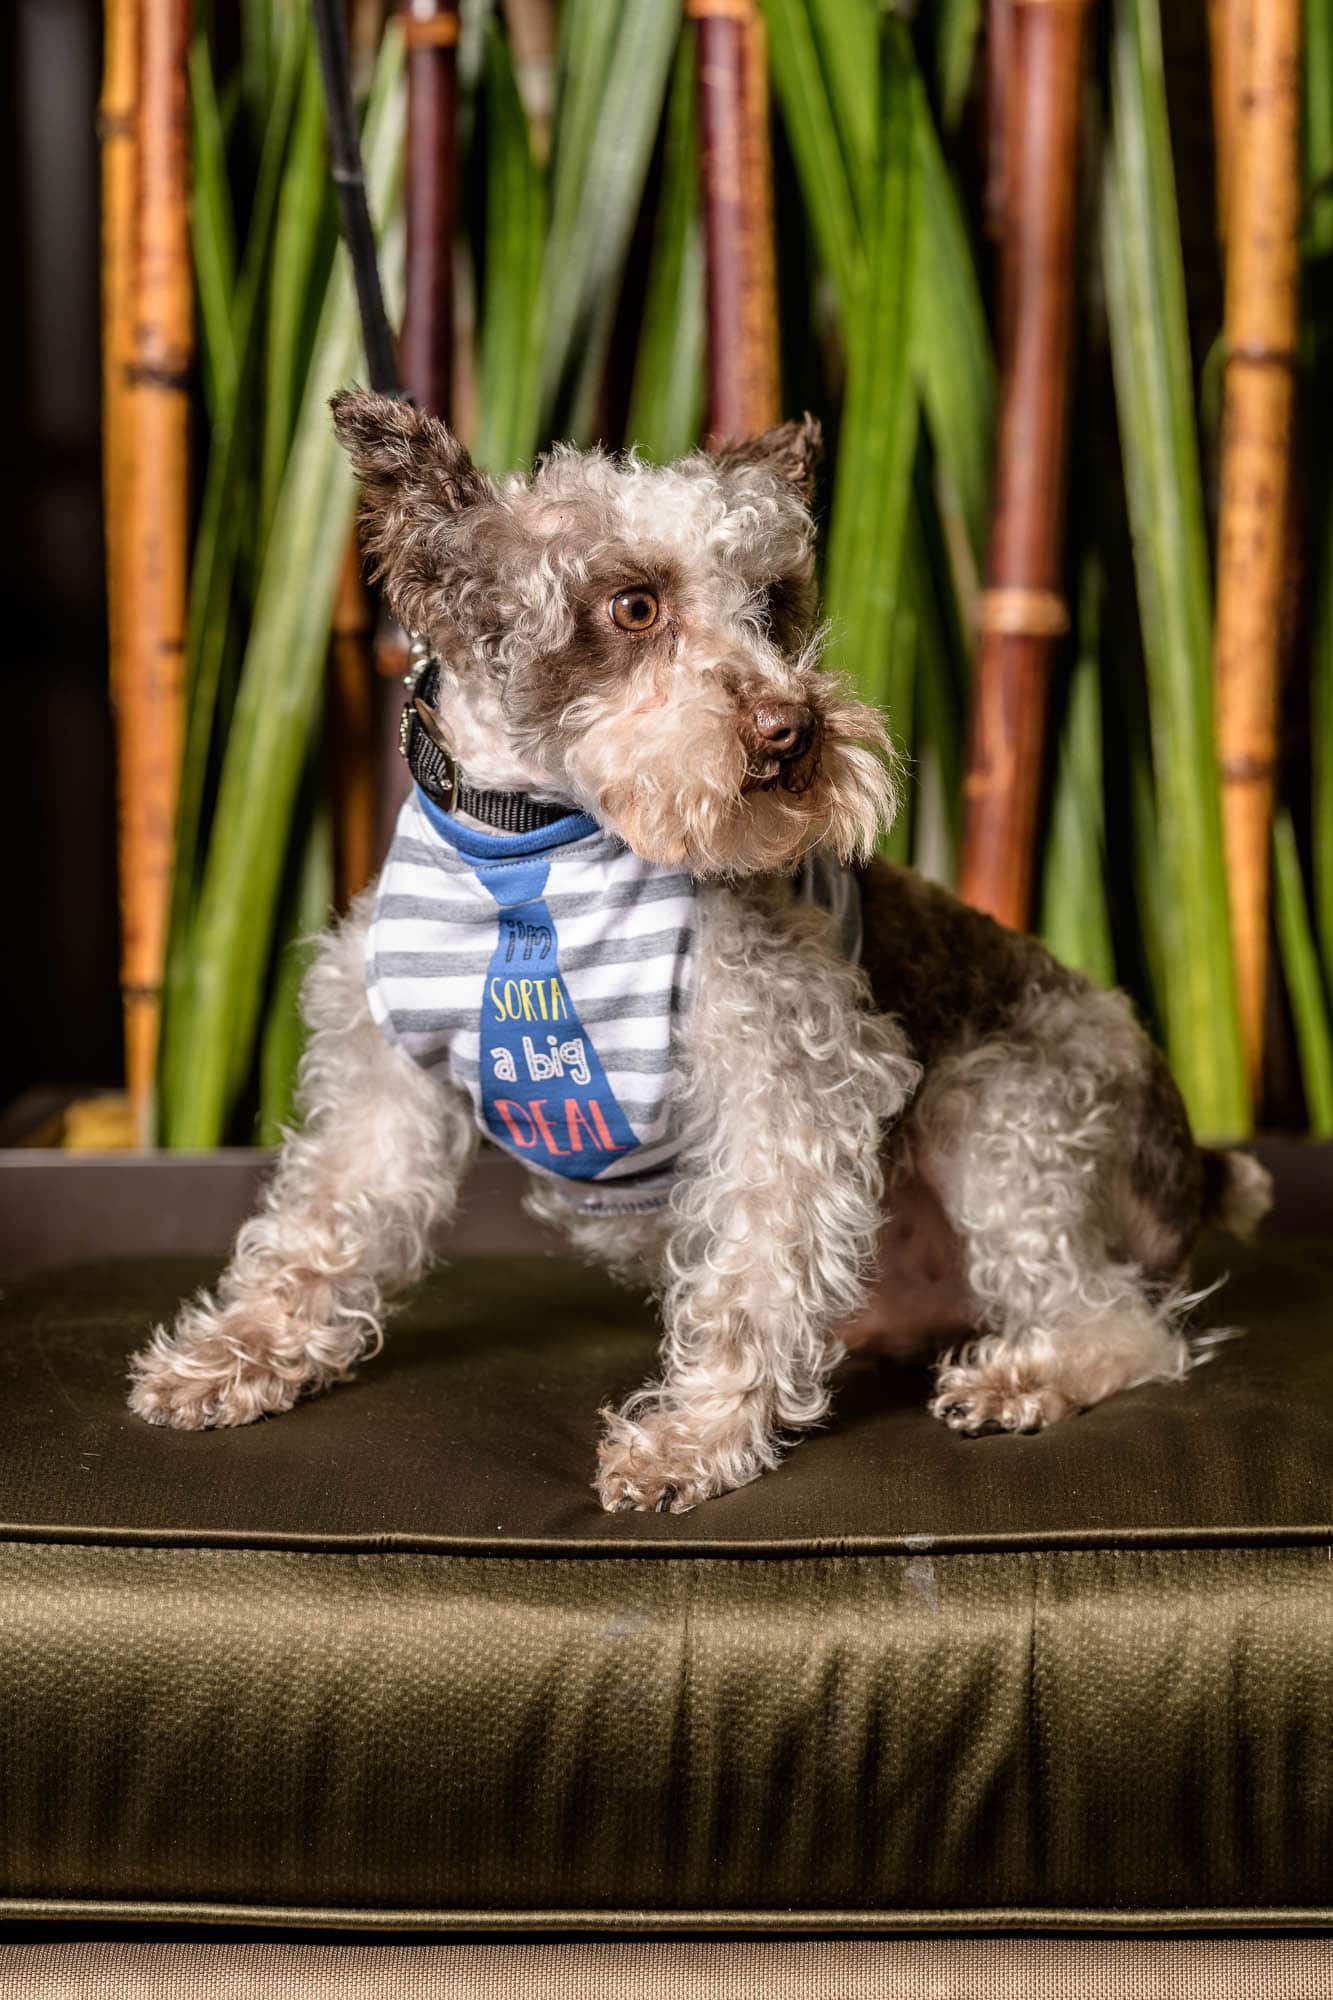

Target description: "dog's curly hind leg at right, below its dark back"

left=911, top=988, right=1201, bottom=1436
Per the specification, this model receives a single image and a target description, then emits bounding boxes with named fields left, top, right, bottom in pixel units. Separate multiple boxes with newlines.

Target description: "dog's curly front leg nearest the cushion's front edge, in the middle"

left=596, top=882, right=919, bottom=1512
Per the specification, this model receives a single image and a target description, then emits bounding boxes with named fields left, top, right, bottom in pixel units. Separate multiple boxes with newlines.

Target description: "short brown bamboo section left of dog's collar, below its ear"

left=328, top=532, right=378, bottom=910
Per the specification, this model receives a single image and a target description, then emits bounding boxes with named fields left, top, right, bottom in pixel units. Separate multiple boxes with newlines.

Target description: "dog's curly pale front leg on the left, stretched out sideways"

left=130, top=904, right=476, bottom=1430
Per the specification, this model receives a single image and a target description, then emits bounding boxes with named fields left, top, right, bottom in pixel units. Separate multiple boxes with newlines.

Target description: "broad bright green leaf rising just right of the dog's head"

left=825, top=22, right=919, bottom=820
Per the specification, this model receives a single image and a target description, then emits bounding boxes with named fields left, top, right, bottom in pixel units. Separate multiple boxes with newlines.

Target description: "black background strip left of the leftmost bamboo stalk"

left=0, top=0, right=122, bottom=1108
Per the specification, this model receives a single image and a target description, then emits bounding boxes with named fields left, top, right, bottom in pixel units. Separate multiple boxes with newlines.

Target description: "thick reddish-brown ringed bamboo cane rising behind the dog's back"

left=959, top=0, right=1087, bottom=928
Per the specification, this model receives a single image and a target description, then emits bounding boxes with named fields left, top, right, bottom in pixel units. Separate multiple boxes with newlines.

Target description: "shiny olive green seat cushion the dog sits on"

left=0, top=1244, right=1333, bottom=1930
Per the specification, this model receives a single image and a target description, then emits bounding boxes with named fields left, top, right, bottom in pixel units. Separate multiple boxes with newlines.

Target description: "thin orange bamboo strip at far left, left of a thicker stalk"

left=98, top=0, right=138, bottom=694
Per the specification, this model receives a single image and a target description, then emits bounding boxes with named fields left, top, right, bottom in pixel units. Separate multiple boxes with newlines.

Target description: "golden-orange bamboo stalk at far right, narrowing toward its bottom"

left=1213, top=0, right=1301, bottom=1094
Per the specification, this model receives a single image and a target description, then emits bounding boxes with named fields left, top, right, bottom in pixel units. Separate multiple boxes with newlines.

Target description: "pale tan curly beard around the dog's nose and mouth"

left=564, top=674, right=897, bottom=876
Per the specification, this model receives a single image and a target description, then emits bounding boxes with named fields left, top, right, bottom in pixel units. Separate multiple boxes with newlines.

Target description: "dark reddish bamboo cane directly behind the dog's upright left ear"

left=374, top=0, right=458, bottom=854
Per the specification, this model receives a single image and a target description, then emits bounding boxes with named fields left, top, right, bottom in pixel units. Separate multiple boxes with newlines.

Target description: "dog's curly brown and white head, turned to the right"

left=334, top=390, right=895, bottom=874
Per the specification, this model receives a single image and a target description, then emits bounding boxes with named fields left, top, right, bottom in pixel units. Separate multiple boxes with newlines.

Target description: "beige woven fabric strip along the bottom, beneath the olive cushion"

left=0, top=1938, right=1333, bottom=2000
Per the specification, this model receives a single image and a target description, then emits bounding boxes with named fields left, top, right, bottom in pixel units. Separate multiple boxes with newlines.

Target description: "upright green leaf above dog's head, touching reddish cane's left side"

left=626, top=34, right=707, bottom=464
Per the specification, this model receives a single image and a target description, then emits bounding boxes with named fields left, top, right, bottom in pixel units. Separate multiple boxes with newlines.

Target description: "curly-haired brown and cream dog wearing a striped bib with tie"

left=132, top=392, right=1267, bottom=1510
